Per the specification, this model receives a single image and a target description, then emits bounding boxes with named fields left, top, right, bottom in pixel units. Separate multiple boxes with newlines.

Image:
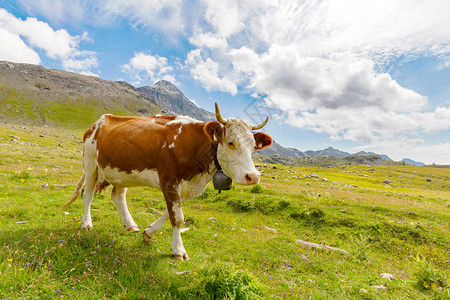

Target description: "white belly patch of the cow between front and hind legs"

left=98, top=166, right=160, bottom=189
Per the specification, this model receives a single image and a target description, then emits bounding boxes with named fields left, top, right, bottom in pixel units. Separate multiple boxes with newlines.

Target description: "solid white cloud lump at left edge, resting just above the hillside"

left=0, top=28, right=41, bottom=65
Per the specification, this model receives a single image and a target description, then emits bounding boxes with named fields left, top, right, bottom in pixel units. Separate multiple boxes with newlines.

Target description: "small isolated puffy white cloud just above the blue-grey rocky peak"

left=122, top=52, right=179, bottom=85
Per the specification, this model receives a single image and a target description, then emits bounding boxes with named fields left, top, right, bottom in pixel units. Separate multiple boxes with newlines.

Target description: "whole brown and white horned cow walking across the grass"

left=63, top=103, right=272, bottom=260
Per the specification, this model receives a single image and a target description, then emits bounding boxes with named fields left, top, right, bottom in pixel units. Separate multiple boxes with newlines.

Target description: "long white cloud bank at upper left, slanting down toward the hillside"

left=0, top=9, right=97, bottom=72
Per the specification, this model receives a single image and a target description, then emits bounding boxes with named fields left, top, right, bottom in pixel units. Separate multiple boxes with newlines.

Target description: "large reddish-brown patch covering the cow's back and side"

left=97, top=115, right=213, bottom=186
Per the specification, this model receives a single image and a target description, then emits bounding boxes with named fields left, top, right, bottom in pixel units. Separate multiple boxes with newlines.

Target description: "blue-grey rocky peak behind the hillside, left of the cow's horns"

left=137, top=80, right=215, bottom=121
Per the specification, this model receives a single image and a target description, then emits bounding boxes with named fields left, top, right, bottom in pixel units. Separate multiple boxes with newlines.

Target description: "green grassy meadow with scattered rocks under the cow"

left=0, top=123, right=450, bottom=299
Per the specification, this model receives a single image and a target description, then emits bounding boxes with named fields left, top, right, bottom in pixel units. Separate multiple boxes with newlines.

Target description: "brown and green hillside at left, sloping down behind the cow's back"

left=0, top=61, right=161, bottom=128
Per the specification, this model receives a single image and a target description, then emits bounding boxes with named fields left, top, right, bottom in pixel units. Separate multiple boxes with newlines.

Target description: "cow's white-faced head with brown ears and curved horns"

left=204, top=103, right=272, bottom=184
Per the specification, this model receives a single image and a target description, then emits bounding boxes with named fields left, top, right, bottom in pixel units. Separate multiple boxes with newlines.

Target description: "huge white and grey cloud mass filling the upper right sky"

left=179, top=0, right=450, bottom=150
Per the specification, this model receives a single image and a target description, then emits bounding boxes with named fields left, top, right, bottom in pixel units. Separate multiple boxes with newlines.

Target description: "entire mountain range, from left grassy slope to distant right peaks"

left=0, top=61, right=425, bottom=166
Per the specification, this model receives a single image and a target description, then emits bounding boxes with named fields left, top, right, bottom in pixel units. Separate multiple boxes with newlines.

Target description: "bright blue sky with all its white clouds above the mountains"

left=0, top=0, right=450, bottom=164
